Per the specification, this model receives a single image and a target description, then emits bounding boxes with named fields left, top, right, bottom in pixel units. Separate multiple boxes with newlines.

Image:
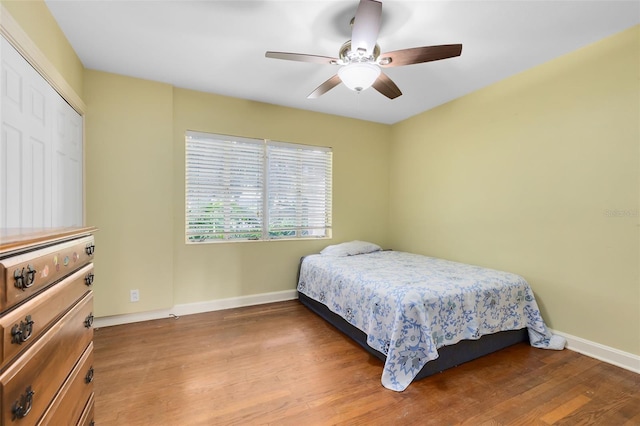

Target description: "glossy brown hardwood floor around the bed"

left=94, top=301, right=640, bottom=426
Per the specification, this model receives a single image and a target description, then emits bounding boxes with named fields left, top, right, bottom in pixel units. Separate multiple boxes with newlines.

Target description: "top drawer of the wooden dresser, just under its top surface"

left=0, top=236, right=95, bottom=311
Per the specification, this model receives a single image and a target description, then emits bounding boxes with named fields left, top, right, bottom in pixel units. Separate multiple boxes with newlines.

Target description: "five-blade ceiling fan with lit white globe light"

left=265, top=0, right=462, bottom=99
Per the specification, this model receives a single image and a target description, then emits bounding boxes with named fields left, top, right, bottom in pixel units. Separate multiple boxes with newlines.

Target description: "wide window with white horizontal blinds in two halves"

left=185, top=131, right=332, bottom=243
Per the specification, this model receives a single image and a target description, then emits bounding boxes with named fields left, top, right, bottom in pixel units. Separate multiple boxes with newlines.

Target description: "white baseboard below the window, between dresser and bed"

left=93, top=290, right=298, bottom=328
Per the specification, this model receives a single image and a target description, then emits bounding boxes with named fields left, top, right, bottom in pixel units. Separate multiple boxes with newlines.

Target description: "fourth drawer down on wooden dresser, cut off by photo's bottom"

left=38, top=343, right=93, bottom=426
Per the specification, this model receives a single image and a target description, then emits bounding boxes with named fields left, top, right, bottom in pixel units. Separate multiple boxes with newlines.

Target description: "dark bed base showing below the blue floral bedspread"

left=298, top=293, right=529, bottom=380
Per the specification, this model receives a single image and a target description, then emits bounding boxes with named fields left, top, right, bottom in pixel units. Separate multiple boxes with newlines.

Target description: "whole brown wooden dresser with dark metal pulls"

left=0, top=228, right=95, bottom=426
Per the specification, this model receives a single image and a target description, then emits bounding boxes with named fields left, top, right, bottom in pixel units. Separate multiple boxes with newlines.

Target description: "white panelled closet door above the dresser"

left=0, top=37, right=83, bottom=228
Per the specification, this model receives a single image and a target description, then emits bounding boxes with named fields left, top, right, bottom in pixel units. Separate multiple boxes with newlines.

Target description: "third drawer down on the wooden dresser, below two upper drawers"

left=0, top=292, right=93, bottom=426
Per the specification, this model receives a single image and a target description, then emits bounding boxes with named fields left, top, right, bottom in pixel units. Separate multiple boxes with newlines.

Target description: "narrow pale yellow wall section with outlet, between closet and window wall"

left=84, top=70, right=174, bottom=316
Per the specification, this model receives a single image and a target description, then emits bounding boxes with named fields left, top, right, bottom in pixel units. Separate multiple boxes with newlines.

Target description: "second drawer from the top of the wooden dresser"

left=0, top=263, right=93, bottom=368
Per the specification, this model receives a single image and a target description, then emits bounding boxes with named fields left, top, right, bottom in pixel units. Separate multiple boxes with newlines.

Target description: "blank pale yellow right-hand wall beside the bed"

left=390, top=27, right=640, bottom=354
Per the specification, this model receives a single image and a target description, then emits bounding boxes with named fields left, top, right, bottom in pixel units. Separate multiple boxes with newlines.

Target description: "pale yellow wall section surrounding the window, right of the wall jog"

left=173, top=89, right=390, bottom=304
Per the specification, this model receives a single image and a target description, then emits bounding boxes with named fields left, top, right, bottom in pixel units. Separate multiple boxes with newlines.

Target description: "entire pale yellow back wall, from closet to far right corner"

left=84, top=76, right=390, bottom=316
